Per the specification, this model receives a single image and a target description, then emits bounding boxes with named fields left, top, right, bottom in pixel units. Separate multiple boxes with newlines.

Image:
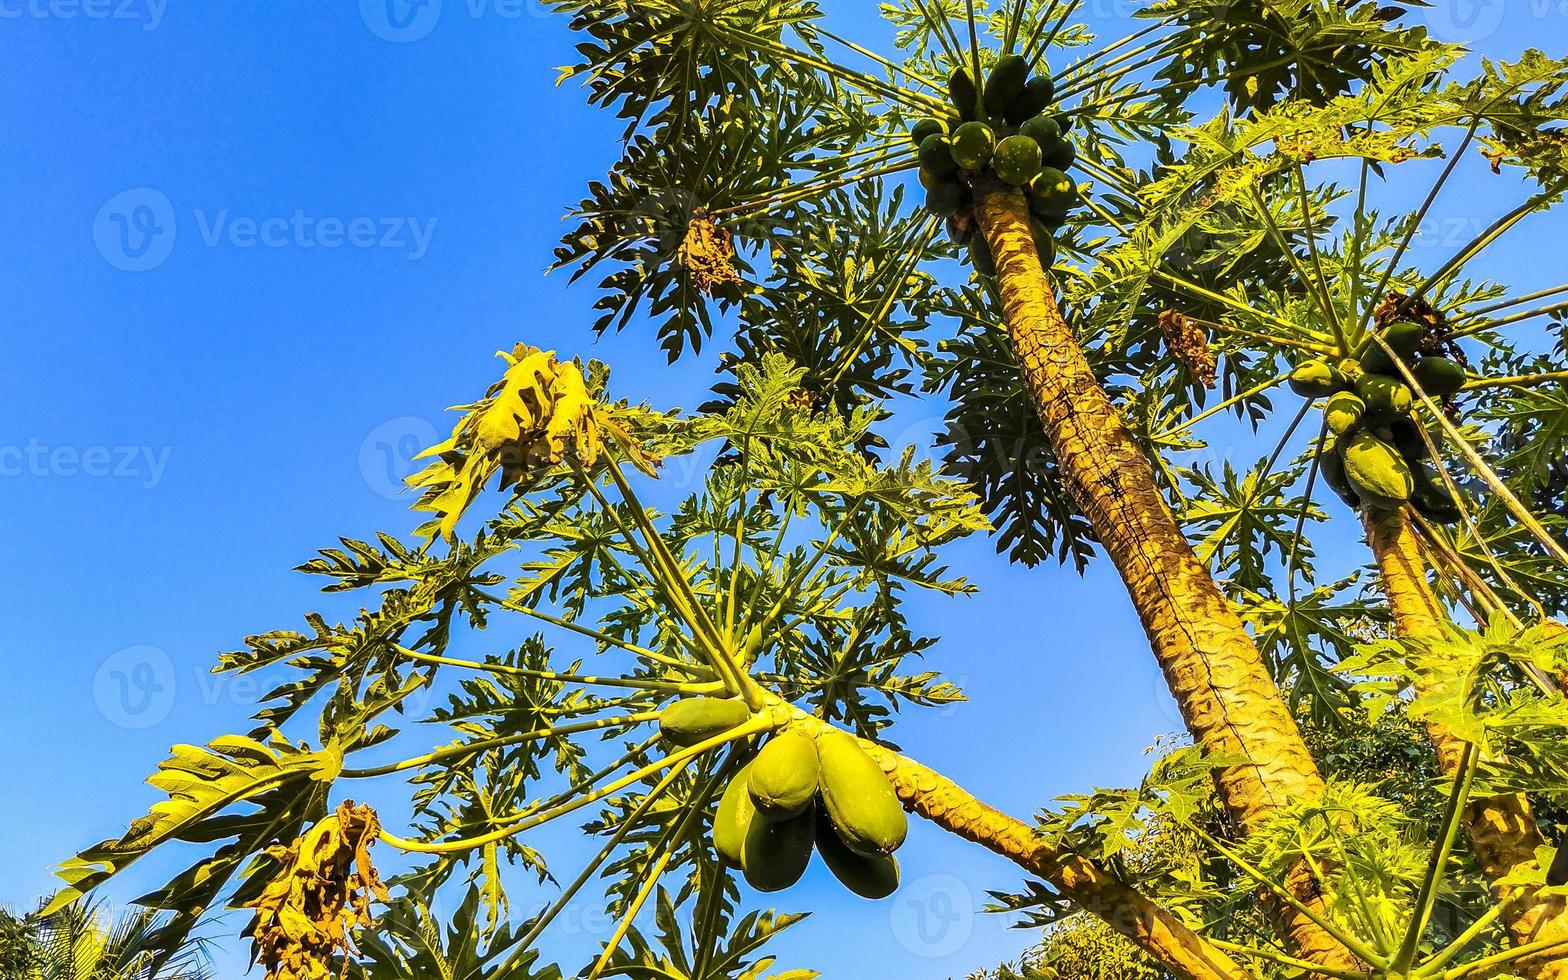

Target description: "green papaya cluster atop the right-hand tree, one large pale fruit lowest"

left=1290, top=321, right=1466, bottom=524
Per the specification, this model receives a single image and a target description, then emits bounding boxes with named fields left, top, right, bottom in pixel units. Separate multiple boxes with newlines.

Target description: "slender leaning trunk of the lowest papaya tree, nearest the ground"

left=789, top=709, right=1254, bottom=980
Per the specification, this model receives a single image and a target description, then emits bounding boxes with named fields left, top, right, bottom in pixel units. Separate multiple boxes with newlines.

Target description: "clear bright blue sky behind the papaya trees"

left=0, top=0, right=1565, bottom=980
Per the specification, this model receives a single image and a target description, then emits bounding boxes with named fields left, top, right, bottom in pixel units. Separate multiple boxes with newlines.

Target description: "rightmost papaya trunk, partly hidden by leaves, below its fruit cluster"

left=1366, top=511, right=1568, bottom=980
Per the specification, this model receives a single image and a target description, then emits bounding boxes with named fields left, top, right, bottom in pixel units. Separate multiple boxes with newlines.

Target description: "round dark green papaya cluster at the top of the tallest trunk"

left=909, top=55, right=1077, bottom=276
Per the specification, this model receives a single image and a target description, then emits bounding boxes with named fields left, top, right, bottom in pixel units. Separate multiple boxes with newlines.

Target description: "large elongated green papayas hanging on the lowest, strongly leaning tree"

left=660, top=698, right=909, bottom=898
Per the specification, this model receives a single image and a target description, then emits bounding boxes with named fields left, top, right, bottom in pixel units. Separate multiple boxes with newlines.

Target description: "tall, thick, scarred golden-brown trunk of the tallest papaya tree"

left=975, top=185, right=1359, bottom=969
